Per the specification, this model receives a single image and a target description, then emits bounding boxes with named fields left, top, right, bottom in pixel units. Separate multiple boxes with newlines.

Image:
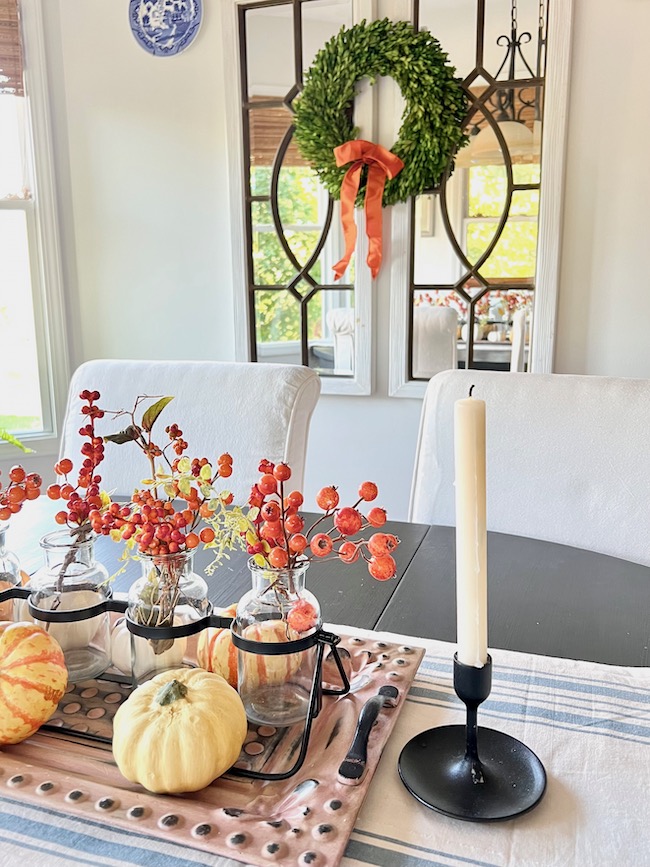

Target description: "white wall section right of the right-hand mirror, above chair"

left=555, top=0, right=650, bottom=378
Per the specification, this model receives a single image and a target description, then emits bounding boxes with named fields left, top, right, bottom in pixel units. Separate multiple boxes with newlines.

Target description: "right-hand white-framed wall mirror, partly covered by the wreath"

left=390, top=0, right=571, bottom=396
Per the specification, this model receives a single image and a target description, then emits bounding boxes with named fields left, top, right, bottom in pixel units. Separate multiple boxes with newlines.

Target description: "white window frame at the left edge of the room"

left=0, top=0, right=70, bottom=460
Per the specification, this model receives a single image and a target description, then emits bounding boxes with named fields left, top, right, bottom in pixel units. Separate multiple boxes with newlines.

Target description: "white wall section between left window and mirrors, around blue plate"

left=43, top=0, right=234, bottom=363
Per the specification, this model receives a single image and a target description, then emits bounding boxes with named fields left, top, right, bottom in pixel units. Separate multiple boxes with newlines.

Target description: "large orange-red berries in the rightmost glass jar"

left=247, top=460, right=399, bottom=581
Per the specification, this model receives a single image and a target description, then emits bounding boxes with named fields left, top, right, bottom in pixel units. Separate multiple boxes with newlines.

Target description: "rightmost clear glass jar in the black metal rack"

left=233, top=560, right=322, bottom=726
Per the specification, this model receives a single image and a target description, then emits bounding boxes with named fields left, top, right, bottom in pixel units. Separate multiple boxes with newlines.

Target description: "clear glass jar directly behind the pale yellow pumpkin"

left=125, top=551, right=212, bottom=683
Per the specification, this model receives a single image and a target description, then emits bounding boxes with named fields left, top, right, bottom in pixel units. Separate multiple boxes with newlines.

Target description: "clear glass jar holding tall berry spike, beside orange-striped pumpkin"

left=23, top=530, right=111, bottom=683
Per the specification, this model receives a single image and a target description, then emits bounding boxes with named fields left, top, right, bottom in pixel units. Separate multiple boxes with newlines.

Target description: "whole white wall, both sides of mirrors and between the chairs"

left=6, top=0, right=650, bottom=518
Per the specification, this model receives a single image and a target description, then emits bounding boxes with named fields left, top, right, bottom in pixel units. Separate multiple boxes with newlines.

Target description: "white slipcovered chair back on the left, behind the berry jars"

left=60, top=360, right=320, bottom=504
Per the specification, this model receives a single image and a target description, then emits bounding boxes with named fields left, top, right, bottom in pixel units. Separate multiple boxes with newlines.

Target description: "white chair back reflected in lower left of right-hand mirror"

left=413, top=305, right=458, bottom=379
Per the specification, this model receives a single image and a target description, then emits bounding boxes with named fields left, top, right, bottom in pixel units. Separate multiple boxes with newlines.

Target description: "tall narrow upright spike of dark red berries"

left=47, top=389, right=104, bottom=528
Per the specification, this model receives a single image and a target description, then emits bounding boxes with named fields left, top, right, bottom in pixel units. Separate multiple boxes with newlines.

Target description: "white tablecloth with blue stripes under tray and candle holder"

left=0, top=627, right=650, bottom=867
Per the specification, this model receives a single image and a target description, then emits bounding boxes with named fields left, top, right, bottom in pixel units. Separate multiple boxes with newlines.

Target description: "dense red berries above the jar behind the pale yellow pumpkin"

left=90, top=450, right=232, bottom=557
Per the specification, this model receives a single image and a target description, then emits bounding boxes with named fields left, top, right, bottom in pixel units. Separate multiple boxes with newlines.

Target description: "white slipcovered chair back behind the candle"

left=409, top=370, right=650, bottom=568
